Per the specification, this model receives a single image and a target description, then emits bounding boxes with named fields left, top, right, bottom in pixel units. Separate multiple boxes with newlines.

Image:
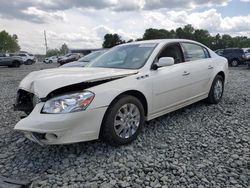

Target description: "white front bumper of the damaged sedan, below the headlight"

left=15, top=103, right=107, bottom=145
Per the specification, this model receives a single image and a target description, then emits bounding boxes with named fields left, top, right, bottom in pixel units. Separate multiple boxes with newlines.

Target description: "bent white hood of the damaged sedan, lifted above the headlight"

left=19, top=67, right=138, bottom=98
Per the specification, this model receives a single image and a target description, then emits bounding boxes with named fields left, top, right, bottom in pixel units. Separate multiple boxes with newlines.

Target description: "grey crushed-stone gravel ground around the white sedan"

left=0, top=63, right=250, bottom=188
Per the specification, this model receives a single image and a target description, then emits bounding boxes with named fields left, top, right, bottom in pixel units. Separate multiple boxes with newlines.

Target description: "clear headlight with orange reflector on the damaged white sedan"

left=42, top=91, right=95, bottom=114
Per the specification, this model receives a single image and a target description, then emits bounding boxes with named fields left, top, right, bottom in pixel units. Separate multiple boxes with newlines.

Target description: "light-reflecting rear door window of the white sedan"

left=182, top=43, right=209, bottom=61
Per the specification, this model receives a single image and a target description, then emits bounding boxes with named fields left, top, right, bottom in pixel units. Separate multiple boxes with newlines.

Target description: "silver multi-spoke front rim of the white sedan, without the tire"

left=114, top=103, right=141, bottom=138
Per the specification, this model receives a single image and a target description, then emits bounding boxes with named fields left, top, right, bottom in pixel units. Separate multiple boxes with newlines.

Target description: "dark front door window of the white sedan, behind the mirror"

left=158, top=44, right=184, bottom=64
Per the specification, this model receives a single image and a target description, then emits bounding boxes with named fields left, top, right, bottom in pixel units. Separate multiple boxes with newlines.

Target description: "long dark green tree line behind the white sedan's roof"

left=103, top=24, right=250, bottom=50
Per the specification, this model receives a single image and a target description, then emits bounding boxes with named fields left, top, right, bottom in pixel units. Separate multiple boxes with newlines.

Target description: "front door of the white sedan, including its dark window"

left=150, top=43, right=198, bottom=114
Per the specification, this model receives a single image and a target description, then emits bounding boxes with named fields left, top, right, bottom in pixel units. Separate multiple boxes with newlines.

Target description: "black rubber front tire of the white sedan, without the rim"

left=101, top=95, right=145, bottom=145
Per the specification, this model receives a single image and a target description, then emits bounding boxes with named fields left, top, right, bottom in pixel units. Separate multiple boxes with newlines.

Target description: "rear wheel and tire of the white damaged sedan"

left=207, top=75, right=224, bottom=104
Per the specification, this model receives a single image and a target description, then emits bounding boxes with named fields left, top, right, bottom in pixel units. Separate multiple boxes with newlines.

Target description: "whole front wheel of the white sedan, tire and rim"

left=100, top=95, right=145, bottom=145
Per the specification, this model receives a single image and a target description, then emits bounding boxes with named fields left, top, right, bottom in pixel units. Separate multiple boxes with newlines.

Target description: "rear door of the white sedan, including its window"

left=181, top=42, right=214, bottom=98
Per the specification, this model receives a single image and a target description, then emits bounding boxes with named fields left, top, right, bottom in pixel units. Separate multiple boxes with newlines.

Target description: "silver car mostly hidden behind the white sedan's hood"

left=61, top=50, right=107, bottom=67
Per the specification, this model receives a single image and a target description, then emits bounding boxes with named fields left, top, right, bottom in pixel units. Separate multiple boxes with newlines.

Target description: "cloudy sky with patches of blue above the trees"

left=0, top=0, right=250, bottom=54
